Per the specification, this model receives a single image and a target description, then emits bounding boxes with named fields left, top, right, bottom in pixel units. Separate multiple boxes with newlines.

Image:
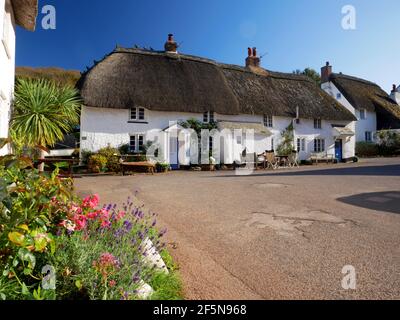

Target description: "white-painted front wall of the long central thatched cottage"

left=81, top=107, right=355, bottom=165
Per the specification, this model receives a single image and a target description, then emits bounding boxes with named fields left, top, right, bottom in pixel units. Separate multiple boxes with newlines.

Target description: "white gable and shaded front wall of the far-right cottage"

left=321, top=82, right=377, bottom=142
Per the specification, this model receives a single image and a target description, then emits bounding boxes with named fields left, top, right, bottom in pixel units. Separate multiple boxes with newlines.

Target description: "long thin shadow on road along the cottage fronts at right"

left=211, top=165, right=400, bottom=178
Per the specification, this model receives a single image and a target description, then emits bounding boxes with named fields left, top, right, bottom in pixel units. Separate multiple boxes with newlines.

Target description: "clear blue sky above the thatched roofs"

left=17, top=0, right=400, bottom=91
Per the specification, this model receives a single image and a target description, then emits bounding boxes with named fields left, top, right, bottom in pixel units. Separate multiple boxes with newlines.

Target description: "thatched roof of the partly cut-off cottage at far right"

left=330, top=73, right=400, bottom=130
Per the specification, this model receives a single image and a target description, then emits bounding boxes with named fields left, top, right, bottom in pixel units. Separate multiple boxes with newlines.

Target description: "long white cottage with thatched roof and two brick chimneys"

left=78, top=35, right=355, bottom=167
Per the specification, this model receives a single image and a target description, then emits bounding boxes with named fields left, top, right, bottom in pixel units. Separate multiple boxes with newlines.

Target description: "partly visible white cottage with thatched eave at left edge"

left=0, top=0, right=37, bottom=155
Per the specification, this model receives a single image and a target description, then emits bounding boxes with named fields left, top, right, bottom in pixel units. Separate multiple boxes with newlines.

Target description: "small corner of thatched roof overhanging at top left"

left=11, top=0, right=38, bottom=31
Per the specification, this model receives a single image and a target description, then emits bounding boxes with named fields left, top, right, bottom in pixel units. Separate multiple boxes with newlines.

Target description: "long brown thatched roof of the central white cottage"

left=78, top=48, right=355, bottom=121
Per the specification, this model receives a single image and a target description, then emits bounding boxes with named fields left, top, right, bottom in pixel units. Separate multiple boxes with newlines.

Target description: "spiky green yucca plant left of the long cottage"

left=11, top=79, right=81, bottom=170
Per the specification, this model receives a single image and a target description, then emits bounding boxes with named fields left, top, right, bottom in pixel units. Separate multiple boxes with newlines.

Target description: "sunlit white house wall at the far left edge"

left=0, top=0, right=15, bottom=155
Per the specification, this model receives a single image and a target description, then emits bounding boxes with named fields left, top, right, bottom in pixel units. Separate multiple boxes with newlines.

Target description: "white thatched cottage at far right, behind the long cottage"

left=321, top=62, right=400, bottom=142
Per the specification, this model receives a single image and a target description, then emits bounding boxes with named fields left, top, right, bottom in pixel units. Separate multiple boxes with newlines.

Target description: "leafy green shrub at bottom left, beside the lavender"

left=0, top=150, right=74, bottom=300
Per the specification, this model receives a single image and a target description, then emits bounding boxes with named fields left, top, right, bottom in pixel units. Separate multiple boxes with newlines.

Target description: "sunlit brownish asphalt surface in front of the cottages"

left=75, top=158, right=400, bottom=299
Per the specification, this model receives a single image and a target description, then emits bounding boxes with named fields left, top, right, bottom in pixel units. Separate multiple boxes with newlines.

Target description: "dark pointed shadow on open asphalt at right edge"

left=337, top=191, right=400, bottom=214
